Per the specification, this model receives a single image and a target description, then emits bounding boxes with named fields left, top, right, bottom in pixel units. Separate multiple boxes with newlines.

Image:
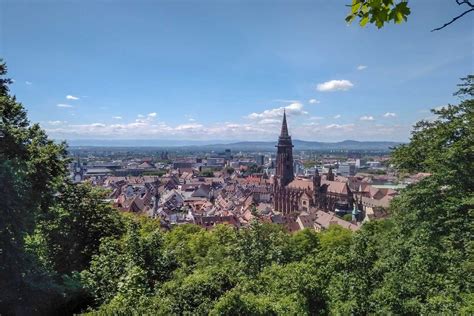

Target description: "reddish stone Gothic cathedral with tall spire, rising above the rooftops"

left=273, top=112, right=353, bottom=214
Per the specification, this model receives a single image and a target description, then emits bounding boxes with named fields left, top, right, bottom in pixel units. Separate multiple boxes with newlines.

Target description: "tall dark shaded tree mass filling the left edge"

left=0, top=61, right=124, bottom=314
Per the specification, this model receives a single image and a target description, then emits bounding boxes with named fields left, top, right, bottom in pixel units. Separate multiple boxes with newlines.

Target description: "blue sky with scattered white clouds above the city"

left=0, top=0, right=474, bottom=141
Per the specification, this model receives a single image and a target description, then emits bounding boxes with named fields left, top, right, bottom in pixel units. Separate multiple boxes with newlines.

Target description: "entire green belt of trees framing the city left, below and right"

left=0, top=61, right=474, bottom=315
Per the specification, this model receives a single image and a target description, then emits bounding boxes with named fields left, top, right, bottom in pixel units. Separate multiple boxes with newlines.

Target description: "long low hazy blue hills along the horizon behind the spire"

left=68, top=139, right=401, bottom=151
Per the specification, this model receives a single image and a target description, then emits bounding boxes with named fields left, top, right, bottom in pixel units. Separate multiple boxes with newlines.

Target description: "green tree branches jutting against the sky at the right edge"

left=391, top=75, right=474, bottom=192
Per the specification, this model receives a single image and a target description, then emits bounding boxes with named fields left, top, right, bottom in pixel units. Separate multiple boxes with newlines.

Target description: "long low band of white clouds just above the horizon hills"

left=46, top=118, right=411, bottom=141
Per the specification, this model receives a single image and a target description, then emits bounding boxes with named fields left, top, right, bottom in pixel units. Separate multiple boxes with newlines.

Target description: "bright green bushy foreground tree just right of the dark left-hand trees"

left=81, top=217, right=176, bottom=310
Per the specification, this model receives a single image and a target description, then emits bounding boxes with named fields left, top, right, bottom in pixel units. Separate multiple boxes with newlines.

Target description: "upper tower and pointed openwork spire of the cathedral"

left=275, top=112, right=294, bottom=187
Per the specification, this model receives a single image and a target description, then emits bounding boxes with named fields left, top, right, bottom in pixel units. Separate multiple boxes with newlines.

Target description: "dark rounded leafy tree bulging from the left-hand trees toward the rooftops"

left=35, top=182, right=124, bottom=274
